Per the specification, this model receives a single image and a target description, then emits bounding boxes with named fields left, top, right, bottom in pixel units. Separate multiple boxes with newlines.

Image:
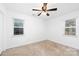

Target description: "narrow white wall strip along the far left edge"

left=0, top=4, right=6, bottom=53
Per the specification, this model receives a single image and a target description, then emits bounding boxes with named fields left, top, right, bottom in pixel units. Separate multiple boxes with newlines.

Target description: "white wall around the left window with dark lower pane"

left=4, top=12, right=45, bottom=49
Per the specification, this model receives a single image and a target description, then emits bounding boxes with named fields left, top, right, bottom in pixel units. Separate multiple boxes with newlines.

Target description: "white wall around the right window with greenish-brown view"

left=47, top=11, right=79, bottom=49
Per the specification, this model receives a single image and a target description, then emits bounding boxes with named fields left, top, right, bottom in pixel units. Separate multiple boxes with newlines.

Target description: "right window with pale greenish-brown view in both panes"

left=65, top=19, right=76, bottom=35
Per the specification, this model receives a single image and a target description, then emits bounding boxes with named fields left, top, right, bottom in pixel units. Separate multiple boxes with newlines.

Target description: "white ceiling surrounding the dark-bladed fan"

left=4, top=3, right=79, bottom=19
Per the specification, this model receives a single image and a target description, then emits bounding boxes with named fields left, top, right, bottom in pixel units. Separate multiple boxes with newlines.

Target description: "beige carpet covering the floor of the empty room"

left=2, top=40, right=79, bottom=56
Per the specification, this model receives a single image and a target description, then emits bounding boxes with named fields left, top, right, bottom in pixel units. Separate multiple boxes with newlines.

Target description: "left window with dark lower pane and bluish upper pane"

left=14, top=19, right=24, bottom=35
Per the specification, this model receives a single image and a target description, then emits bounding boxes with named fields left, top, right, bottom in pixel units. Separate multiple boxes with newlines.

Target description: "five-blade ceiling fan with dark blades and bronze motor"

left=32, top=3, right=57, bottom=16
